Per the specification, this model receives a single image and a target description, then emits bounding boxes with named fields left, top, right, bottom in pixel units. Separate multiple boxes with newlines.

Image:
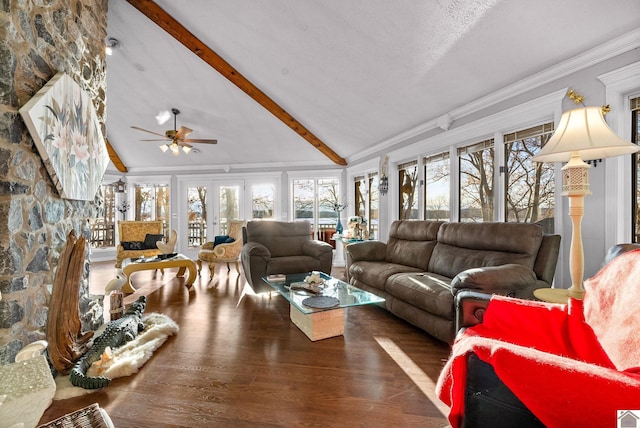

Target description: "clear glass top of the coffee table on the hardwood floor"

left=263, top=272, right=384, bottom=314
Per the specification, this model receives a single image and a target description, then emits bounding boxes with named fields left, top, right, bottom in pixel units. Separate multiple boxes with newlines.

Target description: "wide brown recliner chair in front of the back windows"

left=240, top=221, right=333, bottom=293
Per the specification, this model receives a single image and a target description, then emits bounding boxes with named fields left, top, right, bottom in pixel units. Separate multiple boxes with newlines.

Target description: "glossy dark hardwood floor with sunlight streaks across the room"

left=41, top=262, right=449, bottom=428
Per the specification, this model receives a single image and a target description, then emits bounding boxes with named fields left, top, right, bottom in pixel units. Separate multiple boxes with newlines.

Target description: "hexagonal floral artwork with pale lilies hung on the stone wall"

left=20, top=72, right=109, bottom=201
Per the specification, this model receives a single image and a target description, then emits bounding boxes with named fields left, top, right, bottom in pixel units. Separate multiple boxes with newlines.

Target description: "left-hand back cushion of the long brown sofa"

left=386, top=220, right=443, bottom=271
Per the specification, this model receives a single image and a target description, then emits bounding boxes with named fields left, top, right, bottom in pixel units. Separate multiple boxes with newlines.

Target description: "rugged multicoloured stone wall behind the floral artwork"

left=0, top=0, right=108, bottom=364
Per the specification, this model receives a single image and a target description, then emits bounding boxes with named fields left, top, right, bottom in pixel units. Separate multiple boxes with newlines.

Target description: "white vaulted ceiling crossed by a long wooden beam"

left=107, top=0, right=640, bottom=173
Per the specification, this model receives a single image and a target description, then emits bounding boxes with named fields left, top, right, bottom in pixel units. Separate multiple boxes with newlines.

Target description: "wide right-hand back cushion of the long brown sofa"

left=427, top=222, right=543, bottom=278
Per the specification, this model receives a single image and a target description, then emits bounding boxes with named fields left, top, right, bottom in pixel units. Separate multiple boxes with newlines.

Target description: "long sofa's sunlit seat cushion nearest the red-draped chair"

left=385, top=272, right=454, bottom=320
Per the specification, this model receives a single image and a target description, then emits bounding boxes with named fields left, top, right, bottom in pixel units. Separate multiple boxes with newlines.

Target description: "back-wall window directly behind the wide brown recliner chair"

left=292, top=178, right=342, bottom=237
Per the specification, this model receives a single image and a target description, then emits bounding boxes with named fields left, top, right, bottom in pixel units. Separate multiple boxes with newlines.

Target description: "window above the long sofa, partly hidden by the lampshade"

left=504, top=123, right=555, bottom=233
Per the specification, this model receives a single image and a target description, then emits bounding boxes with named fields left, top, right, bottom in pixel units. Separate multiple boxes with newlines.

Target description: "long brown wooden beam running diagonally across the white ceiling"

left=127, top=0, right=347, bottom=166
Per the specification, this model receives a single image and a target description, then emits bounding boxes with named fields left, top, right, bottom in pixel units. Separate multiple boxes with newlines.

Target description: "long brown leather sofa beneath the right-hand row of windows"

left=345, top=220, right=560, bottom=343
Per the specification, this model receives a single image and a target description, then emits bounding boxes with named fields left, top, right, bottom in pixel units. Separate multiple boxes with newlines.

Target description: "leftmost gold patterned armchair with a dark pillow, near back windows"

left=116, top=220, right=164, bottom=268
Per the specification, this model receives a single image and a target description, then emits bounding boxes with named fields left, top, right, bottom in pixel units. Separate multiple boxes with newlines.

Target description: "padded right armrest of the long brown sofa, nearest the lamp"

left=451, top=264, right=537, bottom=297
